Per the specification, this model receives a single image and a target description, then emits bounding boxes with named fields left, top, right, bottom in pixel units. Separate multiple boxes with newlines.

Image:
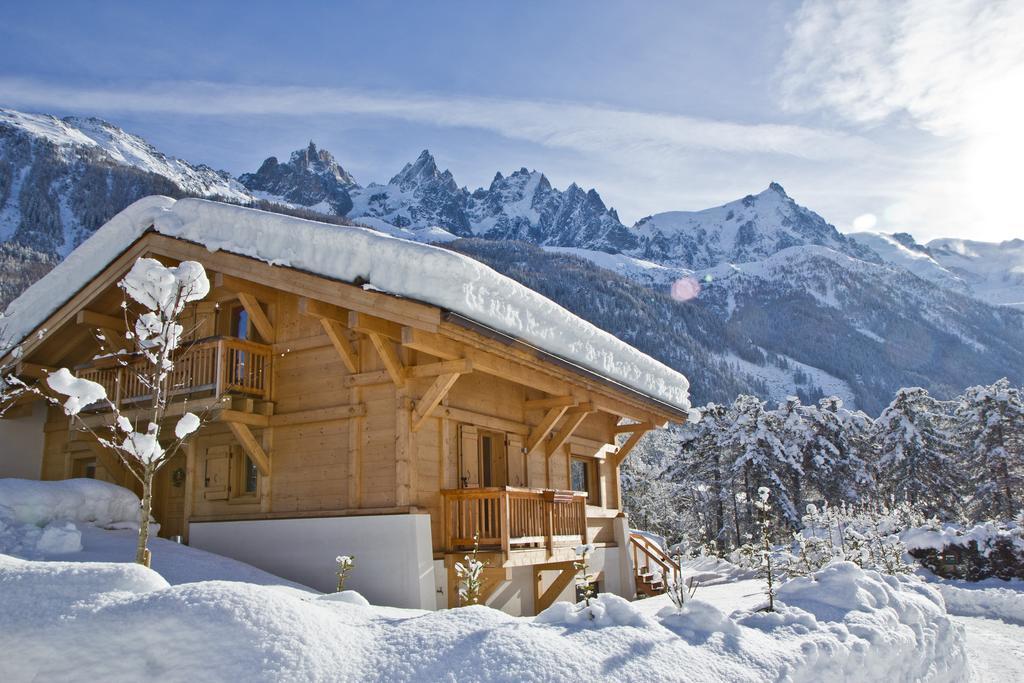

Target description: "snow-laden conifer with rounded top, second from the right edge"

left=874, top=387, right=962, bottom=516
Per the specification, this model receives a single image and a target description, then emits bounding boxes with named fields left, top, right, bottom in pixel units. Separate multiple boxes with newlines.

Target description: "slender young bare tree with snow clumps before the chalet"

left=32, top=258, right=210, bottom=566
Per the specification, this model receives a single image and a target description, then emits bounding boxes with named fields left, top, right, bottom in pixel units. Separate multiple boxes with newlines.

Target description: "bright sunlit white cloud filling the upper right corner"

left=778, top=0, right=1024, bottom=239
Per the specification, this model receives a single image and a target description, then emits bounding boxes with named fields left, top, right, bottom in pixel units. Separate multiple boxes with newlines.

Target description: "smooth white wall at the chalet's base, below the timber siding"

left=188, top=514, right=437, bottom=609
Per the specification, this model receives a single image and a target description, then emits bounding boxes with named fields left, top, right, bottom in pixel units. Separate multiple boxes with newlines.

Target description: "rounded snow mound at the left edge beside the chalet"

left=0, top=479, right=139, bottom=526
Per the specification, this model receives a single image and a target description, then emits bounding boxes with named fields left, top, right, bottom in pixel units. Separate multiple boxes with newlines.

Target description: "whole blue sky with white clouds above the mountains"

left=0, top=0, right=1024, bottom=239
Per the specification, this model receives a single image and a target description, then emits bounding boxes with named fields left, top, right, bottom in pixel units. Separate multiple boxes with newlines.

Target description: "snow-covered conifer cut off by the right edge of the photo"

left=956, top=378, right=1024, bottom=520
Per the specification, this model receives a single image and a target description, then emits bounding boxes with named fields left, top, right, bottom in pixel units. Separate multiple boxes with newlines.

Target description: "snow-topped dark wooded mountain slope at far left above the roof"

left=0, top=110, right=252, bottom=256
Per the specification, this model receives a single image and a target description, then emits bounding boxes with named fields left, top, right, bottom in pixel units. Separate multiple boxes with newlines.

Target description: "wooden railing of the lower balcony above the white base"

left=441, top=486, right=587, bottom=553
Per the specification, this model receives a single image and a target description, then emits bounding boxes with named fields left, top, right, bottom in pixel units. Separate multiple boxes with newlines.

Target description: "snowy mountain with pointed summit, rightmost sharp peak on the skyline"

left=633, top=182, right=877, bottom=268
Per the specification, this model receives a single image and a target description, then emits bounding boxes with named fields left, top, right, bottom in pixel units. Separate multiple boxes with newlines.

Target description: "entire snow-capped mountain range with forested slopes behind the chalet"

left=0, top=111, right=1024, bottom=412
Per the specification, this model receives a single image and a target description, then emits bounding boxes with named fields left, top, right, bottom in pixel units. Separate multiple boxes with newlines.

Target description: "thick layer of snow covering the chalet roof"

left=4, top=197, right=690, bottom=411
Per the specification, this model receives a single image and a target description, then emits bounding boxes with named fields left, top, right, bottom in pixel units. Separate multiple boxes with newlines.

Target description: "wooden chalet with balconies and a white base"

left=0, top=198, right=687, bottom=613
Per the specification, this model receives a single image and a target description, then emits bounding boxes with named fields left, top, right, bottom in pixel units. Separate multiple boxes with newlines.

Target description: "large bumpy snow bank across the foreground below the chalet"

left=0, top=548, right=968, bottom=683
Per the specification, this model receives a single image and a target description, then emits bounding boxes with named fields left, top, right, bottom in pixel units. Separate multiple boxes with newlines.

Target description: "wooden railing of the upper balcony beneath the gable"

left=76, top=337, right=271, bottom=405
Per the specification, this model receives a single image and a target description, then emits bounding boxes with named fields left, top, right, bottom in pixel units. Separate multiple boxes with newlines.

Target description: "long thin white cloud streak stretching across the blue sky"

left=0, top=79, right=878, bottom=161
